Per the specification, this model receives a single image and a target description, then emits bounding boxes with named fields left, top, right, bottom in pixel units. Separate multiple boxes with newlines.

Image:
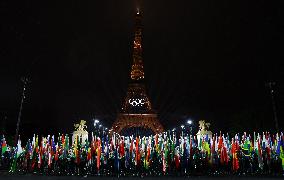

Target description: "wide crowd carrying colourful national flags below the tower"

left=0, top=131, right=284, bottom=176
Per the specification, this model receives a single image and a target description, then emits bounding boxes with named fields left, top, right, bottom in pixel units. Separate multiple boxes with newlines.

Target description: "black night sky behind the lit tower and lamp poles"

left=0, top=0, right=284, bottom=138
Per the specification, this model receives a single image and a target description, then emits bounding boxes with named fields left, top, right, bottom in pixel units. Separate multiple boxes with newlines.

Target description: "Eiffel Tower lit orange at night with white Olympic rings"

left=112, top=10, right=164, bottom=135
